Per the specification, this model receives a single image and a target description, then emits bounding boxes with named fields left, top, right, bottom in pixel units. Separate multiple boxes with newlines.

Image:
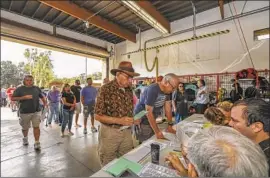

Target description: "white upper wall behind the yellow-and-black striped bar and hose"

left=113, top=1, right=269, bottom=77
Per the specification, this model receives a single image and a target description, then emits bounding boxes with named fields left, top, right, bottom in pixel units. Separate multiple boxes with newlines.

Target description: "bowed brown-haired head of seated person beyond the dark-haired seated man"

left=204, top=107, right=230, bottom=126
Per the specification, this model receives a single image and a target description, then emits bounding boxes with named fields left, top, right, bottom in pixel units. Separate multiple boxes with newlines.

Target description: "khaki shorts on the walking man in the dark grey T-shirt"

left=20, top=112, right=41, bottom=130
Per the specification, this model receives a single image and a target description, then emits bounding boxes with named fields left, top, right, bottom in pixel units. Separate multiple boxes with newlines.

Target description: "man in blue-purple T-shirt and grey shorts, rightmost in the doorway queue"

left=81, top=78, right=97, bottom=134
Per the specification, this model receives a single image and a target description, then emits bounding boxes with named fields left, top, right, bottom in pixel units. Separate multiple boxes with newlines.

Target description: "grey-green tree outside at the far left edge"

left=1, top=61, right=27, bottom=88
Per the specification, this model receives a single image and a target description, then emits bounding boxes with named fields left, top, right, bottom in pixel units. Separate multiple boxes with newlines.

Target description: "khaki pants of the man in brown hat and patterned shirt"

left=98, top=124, right=133, bottom=167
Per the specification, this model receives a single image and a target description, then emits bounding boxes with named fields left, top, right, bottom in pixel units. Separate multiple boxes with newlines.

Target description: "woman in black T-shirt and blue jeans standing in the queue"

left=61, top=84, right=76, bottom=137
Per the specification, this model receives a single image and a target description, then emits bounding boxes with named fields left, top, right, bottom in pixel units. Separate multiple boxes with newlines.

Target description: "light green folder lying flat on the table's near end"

left=106, top=157, right=143, bottom=177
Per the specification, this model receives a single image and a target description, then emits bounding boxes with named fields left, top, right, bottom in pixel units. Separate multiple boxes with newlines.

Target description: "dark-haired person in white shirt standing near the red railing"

left=194, top=79, right=209, bottom=114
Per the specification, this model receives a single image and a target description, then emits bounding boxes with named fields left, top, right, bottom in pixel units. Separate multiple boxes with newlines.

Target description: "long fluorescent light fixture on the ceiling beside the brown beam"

left=122, top=0, right=169, bottom=34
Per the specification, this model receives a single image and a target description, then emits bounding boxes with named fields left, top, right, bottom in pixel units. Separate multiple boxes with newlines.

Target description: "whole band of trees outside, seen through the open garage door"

left=1, top=48, right=102, bottom=88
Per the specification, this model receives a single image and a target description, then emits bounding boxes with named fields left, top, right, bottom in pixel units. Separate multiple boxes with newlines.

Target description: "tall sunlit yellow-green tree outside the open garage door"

left=24, top=49, right=54, bottom=87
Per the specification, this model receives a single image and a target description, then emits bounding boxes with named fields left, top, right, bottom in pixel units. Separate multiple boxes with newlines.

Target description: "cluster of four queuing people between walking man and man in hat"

left=47, top=78, right=97, bottom=137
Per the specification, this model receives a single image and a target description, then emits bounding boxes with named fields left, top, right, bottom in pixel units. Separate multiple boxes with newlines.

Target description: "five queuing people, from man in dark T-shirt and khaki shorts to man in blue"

left=10, top=75, right=97, bottom=150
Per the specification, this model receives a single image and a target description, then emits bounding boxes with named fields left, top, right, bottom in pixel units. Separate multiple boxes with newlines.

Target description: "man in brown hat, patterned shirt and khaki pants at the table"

left=95, top=61, right=139, bottom=166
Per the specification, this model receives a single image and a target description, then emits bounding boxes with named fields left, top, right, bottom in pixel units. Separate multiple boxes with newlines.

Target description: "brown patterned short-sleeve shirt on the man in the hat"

left=95, top=79, right=133, bottom=117
